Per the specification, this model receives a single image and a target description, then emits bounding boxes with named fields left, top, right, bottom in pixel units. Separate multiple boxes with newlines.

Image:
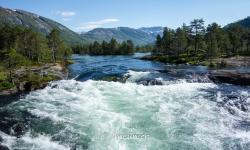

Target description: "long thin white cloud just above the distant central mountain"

left=76, top=19, right=120, bottom=30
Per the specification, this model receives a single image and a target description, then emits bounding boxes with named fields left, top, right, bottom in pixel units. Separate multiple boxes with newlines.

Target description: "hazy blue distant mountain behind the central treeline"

left=81, top=27, right=163, bottom=45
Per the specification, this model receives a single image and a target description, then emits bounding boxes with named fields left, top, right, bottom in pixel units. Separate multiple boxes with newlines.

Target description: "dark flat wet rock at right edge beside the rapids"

left=209, top=70, right=250, bottom=86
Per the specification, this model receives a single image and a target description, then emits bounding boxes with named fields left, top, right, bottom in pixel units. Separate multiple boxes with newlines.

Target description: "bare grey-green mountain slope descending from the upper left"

left=0, top=7, right=84, bottom=44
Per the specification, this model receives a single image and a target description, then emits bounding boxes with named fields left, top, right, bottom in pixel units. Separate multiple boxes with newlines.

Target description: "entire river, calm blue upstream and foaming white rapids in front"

left=0, top=54, right=250, bottom=150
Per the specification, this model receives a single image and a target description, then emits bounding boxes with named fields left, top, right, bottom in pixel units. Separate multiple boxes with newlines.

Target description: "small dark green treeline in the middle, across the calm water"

left=72, top=38, right=135, bottom=55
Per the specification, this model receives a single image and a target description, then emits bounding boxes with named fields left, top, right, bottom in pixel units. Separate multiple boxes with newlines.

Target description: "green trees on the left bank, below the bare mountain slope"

left=0, top=25, right=71, bottom=80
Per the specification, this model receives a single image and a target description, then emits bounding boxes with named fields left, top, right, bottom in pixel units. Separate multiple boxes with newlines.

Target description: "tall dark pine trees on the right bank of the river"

left=153, top=19, right=250, bottom=63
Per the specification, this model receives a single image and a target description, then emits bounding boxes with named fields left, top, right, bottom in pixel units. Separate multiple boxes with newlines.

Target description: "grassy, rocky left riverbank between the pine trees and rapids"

left=0, top=63, right=67, bottom=95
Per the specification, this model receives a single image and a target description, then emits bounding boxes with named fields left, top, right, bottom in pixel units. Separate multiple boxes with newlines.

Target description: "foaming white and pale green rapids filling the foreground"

left=0, top=72, right=250, bottom=150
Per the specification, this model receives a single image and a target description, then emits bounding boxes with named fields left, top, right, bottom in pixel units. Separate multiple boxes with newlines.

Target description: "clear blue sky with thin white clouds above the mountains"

left=0, top=0, right=250, bottom=32
